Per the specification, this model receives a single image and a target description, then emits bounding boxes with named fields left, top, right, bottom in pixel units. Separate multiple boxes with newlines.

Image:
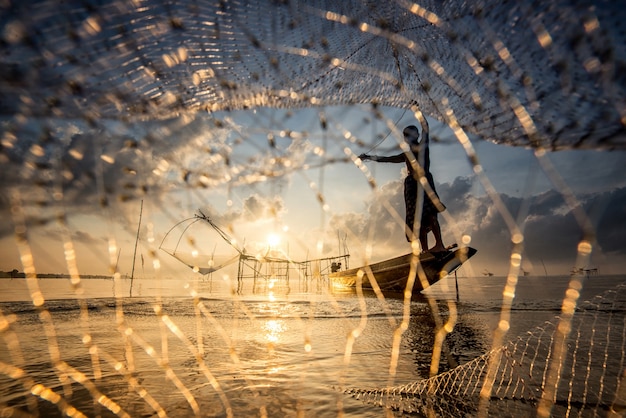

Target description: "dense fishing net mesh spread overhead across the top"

left=0, top=1, right=626, bottom=148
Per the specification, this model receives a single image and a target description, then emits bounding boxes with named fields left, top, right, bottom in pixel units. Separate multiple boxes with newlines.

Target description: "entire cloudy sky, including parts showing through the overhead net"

left=0, top=3, right=626, bottom=277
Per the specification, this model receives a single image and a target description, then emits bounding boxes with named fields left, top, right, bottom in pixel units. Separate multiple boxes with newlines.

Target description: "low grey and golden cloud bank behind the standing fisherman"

left=324, top=177, right=626, bottom=270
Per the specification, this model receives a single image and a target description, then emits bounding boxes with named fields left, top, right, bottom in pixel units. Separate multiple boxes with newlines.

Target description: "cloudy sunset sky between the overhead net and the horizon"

left=0, top=105, right=626, bottom=277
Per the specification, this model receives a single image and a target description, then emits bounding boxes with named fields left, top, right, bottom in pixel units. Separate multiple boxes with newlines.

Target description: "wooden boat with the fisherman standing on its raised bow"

left=328, top=247, right=476, bottom=293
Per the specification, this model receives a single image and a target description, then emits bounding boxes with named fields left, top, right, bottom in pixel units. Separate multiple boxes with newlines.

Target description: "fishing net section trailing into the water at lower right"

left=346, top=285, right=626, bottom=416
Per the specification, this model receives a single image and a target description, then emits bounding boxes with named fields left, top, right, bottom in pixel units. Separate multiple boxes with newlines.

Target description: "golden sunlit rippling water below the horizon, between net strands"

left=0, top=278, right=616, bottom=416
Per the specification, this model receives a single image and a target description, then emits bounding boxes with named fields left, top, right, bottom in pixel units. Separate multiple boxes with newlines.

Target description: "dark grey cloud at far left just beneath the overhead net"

left=0, top=116, right=240, bottom=236
